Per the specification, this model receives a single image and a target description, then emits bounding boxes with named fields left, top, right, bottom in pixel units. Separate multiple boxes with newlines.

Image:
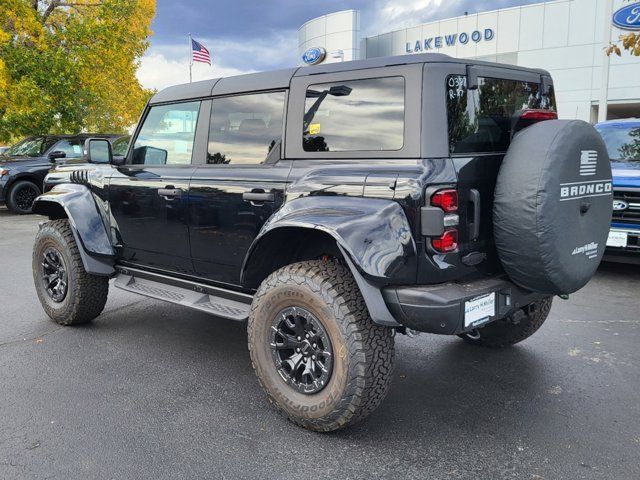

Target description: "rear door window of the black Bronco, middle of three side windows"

left=207, top=92, right=285, bottom=165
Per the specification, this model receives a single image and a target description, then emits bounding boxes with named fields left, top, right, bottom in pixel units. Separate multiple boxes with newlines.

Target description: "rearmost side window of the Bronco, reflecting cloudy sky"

left=303, top=77, right=405, bottom=152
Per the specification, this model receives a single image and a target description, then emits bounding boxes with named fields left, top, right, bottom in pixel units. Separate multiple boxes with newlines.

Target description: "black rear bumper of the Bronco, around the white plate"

left=382, top=277, right=546, bottom=335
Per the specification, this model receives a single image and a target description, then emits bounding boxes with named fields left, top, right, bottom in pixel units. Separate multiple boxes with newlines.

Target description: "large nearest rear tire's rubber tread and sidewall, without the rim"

left=248, top=261, right=394, bottom=432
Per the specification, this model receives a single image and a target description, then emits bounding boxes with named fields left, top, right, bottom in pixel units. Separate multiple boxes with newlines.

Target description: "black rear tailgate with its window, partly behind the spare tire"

left=430, top=66, right=555, bottom=273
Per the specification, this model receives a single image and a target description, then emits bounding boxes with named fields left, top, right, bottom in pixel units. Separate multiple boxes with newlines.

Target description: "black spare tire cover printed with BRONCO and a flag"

left=493, top=120, right=613, bottom=295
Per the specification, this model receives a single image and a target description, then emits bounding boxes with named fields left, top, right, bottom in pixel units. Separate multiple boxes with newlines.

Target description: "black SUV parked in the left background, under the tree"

left=0, top=134, right=120, bottom=214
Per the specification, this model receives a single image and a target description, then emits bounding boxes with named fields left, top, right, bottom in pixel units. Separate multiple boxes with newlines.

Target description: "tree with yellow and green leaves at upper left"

left=0, top=0, right=155, bottom=141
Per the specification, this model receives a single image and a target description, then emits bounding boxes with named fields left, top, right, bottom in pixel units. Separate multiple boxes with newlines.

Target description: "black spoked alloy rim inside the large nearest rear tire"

left=270, top=307, right=333, bottom=395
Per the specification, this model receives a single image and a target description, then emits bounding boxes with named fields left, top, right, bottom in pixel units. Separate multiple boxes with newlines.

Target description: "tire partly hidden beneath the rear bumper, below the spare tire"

left=459, top=297, right=553, bottom=348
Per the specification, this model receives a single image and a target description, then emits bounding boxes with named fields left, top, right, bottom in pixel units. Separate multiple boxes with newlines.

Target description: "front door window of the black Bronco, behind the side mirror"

left=132, top=102, right=200, bottom=165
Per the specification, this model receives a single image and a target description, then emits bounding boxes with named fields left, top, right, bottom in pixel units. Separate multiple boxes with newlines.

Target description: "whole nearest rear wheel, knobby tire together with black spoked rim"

left=248, top=261, right=394, bottom=432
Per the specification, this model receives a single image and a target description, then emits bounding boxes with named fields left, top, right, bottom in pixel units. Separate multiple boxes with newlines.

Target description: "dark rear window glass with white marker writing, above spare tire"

left=447, top=75, right=555, bottom=154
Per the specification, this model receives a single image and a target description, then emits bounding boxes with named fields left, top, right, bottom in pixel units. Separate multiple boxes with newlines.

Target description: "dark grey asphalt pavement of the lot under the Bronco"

left=0, top=209, right=640, bottom=479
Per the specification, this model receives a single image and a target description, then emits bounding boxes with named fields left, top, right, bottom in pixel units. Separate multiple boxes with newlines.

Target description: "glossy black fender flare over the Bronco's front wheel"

left=33, top=184, right=115, bottom=276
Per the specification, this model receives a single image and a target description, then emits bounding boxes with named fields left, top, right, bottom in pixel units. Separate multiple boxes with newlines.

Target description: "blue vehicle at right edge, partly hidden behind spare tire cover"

left=596, top=118, right=640, bottom=263
